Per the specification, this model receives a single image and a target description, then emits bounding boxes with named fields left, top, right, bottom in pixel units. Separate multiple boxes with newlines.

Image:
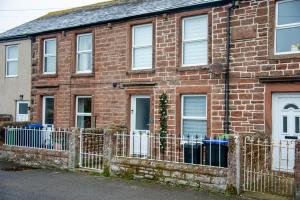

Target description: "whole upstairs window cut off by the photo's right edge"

left=274, top=0, right=300, bottom=55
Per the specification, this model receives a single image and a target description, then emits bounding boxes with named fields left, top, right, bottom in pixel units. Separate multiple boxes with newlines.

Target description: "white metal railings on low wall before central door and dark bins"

left=115, top=131, right=228, bottom=167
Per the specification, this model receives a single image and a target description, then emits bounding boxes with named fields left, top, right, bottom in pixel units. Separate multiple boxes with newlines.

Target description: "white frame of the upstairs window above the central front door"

left=131, top=23, right=153, bottom=70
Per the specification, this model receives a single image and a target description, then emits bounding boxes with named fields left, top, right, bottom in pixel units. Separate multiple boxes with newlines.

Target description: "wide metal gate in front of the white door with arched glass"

left=242, top=137, right=295, bottom=196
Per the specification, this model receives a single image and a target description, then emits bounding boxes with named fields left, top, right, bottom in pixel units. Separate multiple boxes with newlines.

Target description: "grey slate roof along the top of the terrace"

left=0, top=0, right=224, bottom=41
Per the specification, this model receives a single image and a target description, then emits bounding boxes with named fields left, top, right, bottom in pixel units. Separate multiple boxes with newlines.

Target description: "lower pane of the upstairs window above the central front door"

left=133, top=47, right=152, bottom=69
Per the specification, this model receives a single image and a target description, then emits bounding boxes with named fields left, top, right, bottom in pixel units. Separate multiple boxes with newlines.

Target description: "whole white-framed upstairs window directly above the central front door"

left=132, top=24, right=153, bottom=70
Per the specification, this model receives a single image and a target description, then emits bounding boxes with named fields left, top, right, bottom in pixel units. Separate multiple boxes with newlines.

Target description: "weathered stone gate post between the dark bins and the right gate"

left=226, top=135, right=241, bottom=194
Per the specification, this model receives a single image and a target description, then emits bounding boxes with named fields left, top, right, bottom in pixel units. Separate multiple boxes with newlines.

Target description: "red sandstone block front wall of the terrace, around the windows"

left=32, top=0, right=300, bottom=137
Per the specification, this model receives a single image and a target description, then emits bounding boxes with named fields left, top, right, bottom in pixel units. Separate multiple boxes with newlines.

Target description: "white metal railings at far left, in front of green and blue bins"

left=4, top=127, right=70, bottom=151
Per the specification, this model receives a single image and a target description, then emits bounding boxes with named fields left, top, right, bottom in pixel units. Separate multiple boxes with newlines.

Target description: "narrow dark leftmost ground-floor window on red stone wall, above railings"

left=42, top=96, right=54, bottom=125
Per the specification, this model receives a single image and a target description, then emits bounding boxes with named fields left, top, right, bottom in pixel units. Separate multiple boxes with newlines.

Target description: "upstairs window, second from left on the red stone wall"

left=76, top=33, right=93, bottom=73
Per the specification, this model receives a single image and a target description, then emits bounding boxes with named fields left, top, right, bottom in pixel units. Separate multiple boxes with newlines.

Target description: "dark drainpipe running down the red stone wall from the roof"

left=224, top=0, right=238, bottom=134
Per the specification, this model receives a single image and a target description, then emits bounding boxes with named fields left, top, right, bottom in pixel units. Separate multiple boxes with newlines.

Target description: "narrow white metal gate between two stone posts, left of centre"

left=79, top=130, right=104, bottom=171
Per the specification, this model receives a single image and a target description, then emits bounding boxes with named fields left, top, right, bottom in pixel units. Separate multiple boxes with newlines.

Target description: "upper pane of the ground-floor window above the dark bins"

left=183, top=96, right=206, bottom=117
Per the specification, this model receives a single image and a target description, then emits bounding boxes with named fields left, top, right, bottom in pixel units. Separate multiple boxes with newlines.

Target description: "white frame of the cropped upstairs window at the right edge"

left=274, top=0, right=300, bottom=55
